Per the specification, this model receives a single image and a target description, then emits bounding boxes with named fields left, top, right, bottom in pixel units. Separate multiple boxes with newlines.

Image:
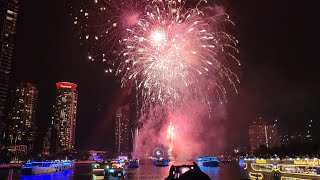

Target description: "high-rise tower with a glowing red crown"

left=52, top=82, right=78, bottom=151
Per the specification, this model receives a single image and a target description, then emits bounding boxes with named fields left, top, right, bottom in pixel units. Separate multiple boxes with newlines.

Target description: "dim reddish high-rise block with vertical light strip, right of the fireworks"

left=249, top=117, right=280, bottom=152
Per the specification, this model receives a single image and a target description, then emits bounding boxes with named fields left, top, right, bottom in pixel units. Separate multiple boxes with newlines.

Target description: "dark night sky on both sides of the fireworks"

left=13, top=0, right=320, bottom=149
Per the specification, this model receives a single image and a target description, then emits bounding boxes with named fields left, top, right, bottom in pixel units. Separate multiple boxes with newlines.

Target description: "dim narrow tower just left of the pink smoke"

left=115, top=105, right=131, bottom=155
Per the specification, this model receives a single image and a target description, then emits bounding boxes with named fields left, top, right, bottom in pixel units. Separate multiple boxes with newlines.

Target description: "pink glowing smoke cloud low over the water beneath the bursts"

left=134, top=102, right=225, bottom=161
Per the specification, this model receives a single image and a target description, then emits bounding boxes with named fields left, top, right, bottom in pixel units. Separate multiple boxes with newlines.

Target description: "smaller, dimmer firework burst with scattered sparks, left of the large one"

left=71, top=0, right=148, bottom=63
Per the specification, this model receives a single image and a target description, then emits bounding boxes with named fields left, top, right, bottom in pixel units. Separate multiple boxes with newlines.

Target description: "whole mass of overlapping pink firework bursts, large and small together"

left=75, top=0, right=240, bottom=107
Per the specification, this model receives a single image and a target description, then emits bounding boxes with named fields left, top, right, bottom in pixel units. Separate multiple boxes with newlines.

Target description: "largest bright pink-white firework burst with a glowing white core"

left=117, top=0, right=240, bottom=106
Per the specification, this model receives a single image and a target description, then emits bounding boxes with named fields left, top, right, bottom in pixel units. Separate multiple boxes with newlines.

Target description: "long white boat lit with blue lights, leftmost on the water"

left=22, top=161, right=73, bottom=175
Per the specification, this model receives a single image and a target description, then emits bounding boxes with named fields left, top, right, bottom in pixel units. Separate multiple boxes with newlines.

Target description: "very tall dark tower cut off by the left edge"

left=0, top=0, right=19, bottom=123
